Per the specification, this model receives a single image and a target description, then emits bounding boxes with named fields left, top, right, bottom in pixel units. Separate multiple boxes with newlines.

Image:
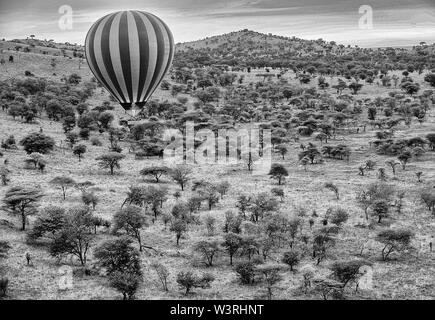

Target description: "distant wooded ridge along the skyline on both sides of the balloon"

left=0, top=29, right=435, bottom=64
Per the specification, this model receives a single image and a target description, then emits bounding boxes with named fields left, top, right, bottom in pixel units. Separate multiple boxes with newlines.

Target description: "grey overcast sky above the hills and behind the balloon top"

left=0, top=0, right=435, bottom=47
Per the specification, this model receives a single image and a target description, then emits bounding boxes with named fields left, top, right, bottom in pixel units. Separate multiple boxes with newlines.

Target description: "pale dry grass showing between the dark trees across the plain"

left=0, top=45, right=435, bottom=299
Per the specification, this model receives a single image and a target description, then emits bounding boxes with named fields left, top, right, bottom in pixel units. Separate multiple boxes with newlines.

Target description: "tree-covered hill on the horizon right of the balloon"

left=175, top=29, right=435, bottom=71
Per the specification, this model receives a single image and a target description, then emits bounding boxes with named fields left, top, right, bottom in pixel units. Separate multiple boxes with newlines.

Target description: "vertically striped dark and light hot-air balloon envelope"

left=85, top=11, right=174, bottom=110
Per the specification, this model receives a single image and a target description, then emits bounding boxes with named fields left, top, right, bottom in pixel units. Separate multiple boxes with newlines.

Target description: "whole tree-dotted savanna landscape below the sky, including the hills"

left=0, top=30, right=435, bottom=300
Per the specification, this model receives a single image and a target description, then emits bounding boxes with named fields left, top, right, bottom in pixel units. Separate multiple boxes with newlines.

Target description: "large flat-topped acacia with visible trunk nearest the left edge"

left=3, top=187, right=43, bottom=231
